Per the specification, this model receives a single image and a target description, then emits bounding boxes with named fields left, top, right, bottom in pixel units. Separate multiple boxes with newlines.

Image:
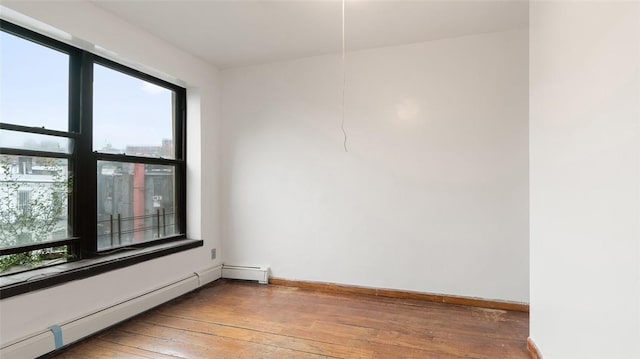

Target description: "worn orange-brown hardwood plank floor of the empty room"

left=55, top=280, right=529, bottom=359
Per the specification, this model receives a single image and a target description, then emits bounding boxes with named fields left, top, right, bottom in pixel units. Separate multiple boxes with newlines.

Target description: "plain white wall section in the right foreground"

left=530, top=1, right=640, bottom=359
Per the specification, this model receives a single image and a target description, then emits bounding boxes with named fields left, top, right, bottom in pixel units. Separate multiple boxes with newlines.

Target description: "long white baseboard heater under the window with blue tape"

left=0, top=266, right=222, bottom=359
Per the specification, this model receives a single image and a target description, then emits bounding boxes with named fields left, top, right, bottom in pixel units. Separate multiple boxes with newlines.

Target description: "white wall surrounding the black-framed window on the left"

left=0, top=1, right=221, bottom=344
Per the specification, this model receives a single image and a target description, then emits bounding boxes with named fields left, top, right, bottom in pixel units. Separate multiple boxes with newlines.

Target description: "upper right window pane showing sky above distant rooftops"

left=93, top=64, right=175, bottom=158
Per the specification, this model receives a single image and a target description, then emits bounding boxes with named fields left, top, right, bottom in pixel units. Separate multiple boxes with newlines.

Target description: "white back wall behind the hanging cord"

left=221, top=30, right=529, bottom=302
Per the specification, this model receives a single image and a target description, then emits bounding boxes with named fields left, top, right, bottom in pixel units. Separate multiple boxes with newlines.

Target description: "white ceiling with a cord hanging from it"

left=92, top=0, right=529, bottom=68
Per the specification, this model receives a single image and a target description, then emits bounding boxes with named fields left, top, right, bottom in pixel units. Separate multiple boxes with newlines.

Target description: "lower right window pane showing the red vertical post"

left=97, top=161, right=179, bottom=250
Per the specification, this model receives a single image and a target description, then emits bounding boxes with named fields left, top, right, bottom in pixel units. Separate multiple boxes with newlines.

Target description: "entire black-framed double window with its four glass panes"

left=0, top=20, right=186, bottom=275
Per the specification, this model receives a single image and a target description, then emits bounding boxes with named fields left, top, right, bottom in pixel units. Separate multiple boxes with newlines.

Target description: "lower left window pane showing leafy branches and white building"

left=0, top=155, right=71, bottom=248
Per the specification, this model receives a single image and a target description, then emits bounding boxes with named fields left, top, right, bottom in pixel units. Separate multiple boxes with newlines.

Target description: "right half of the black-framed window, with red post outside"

left=92, top=62, right=182, bottom=250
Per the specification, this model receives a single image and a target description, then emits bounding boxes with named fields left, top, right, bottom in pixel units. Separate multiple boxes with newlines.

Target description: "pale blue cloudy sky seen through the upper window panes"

left=0, top=32, right=173, bottom=158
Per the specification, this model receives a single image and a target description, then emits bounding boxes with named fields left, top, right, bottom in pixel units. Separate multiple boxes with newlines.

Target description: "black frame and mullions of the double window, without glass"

left=0, top=19, right=189, bottom=276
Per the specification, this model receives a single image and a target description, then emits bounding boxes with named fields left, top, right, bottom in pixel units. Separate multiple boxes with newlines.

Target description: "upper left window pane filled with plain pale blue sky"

left=0, top=32, right=69, bottom=131
